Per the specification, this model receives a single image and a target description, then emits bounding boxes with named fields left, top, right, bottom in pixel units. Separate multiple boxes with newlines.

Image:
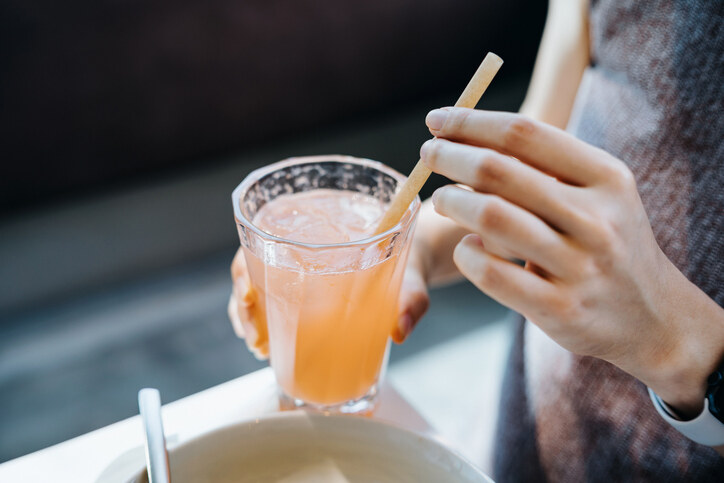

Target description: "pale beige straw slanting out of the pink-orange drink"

left=375, top=52, right=503, bottom=235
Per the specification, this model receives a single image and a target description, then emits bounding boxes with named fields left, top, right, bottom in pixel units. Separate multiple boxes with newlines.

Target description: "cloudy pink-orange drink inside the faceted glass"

left=246, top=189, right=406, bottom=406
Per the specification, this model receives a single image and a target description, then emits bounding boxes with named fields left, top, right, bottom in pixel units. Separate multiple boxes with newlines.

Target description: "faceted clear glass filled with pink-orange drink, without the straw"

left=235, top=157, right=419, bottom=412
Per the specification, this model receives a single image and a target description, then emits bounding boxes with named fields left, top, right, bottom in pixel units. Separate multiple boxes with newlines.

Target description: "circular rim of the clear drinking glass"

left=231, top=154, right=422, bottom=249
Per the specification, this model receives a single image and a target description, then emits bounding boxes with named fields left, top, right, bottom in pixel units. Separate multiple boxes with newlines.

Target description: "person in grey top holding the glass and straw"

left=231, top=0, right=724, bottom=481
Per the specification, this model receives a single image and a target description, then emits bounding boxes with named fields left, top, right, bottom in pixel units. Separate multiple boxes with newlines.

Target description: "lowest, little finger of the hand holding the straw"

left=453, top=235, right=558, bottom=318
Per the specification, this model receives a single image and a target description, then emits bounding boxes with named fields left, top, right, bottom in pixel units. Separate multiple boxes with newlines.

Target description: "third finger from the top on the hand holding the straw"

left=433, top=186, right=575, bottom=277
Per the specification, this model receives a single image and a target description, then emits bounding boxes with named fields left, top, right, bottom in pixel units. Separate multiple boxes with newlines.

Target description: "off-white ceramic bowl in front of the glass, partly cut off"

left=130, top=411, right=492, bottom=483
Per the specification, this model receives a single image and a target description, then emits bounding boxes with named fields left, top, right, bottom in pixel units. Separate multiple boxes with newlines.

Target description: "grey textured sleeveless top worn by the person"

left=495, top=0, right=724, bottom=482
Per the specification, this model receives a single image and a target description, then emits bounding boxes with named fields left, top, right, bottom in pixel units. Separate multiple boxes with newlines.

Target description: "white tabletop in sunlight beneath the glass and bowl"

left=0, top=319, right=512, bottom=483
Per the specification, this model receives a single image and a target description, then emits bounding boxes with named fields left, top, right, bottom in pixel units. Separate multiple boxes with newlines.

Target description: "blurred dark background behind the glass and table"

left=0, top=0, right=546, bottom=462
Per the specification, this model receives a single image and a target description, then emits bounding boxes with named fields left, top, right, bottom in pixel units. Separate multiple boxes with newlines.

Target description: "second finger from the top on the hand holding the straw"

left=420, top=139, right=579, bottom=232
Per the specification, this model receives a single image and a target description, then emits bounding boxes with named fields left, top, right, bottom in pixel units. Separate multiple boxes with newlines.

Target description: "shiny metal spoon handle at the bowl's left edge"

left=138, top=388, right=171, bottom=483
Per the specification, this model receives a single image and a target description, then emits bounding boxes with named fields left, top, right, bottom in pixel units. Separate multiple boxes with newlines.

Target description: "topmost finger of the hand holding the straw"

left=427, top=107, right=620, bottom=186
